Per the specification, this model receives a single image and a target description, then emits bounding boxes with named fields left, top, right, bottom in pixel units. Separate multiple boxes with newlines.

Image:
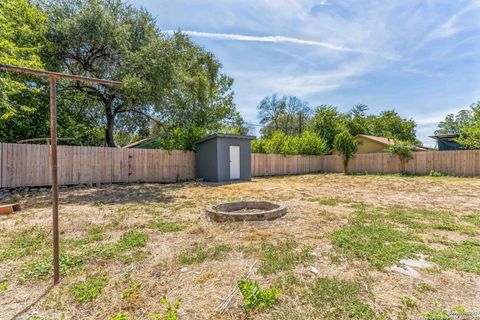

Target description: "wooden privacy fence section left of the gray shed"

left=0, top=143, right=195, bottom=188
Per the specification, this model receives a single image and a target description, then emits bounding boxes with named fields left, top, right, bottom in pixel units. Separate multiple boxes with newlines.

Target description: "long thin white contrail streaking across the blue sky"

left=165, top=30, right=368, bottom=53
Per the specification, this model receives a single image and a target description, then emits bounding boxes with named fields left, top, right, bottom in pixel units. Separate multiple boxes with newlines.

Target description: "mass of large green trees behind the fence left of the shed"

left=0, top=0, right=248, bottom=149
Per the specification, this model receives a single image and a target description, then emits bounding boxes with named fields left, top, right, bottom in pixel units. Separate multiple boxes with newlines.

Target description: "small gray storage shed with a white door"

left=195, top=133, right=255, bottom=182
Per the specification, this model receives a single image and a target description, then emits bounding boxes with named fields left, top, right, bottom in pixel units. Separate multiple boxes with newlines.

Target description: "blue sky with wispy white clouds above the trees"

left=132, top=0, right=480, bottom=145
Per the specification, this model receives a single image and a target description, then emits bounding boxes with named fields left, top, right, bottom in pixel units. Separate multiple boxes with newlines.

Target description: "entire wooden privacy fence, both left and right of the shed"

left=0, top=143, right=480, bottom=188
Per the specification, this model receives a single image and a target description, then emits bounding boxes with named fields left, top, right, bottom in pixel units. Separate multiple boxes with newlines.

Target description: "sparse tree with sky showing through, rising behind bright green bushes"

left=258, top=94, right=311, bottom=138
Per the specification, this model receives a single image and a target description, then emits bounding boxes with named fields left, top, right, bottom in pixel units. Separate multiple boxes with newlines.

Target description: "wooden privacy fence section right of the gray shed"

left=252, top=150, right=480, bottom=177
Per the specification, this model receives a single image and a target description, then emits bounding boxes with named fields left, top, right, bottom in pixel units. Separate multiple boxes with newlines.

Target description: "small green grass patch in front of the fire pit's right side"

left=258, top=239, right=313, bottom=276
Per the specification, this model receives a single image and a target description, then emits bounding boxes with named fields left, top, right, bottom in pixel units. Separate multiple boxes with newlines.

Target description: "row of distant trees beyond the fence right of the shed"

left=258, top=94, right=417, bottom=149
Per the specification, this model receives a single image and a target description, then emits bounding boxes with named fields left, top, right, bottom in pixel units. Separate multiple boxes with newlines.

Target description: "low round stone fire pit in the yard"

left=206, top=200, right=287, bottom=222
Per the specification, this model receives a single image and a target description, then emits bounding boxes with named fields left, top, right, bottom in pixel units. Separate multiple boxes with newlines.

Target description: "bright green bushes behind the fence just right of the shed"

left=251, top=131, right=329, bottom=155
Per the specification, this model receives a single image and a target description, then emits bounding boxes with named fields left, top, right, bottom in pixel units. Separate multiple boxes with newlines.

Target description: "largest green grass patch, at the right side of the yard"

left=332, top=207, right=480, bottom=273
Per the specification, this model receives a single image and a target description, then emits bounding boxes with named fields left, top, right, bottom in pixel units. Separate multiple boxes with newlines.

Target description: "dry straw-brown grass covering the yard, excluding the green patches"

left=0, top=174, right=480, bottom=319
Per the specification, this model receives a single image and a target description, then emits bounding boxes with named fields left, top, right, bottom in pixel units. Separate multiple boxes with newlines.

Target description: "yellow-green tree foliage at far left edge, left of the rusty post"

left=0, top=0, right=48, bottom=142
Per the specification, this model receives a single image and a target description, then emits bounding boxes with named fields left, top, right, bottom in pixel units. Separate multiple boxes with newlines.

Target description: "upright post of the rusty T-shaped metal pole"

left=49, top=75, right=60, bottom=284
